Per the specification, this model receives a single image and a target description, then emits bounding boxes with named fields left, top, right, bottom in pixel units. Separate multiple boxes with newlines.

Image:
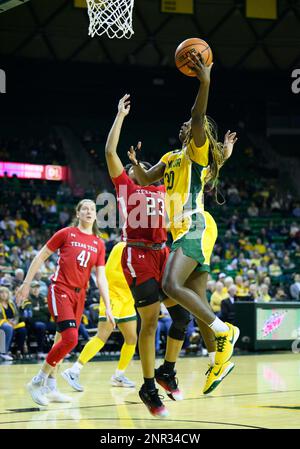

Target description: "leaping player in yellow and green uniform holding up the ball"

left=128, top=54, right=239, bottom=394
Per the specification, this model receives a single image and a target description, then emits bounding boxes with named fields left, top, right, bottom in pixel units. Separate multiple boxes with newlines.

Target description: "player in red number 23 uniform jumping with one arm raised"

left=105, top=95, right=190, bottom=416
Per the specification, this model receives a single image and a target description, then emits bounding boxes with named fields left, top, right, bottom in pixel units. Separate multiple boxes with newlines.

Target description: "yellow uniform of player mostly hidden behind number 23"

left=99, top=242, right=137, bottom=323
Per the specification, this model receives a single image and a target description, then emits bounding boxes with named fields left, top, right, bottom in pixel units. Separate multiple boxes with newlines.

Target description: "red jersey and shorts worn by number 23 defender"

left=112, top=169, right=169, bottom=290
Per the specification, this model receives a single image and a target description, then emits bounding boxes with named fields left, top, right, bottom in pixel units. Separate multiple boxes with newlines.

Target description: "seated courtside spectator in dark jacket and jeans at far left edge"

left=0, top=287, right=27, bottom=361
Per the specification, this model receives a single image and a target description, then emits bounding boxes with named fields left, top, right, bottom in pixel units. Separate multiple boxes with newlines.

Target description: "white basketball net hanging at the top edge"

left=86, top=0, right=134, bottom=39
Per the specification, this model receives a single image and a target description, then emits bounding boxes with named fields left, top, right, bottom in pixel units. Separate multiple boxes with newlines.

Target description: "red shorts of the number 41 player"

left=47, top=284, right=86, bottom=328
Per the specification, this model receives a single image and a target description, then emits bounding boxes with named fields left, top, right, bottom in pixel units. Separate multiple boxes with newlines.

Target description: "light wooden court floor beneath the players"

left=0, top=352, right=300, bottom=429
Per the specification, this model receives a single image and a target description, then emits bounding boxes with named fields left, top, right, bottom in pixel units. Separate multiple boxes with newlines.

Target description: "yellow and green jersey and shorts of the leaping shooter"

left=161, top=139, right=218, bottom=272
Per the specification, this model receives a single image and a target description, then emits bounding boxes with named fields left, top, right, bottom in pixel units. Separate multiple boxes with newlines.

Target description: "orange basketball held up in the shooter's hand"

left=175, top=37, right=213, bottom=76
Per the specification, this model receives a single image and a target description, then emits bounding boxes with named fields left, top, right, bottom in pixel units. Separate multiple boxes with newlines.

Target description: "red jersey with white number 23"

left=112, top=170, right=167, bottom=243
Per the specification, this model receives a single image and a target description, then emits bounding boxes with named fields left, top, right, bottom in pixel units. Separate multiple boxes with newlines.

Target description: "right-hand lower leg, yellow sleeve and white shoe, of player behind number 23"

left=111, top=320, right=137, bottom=388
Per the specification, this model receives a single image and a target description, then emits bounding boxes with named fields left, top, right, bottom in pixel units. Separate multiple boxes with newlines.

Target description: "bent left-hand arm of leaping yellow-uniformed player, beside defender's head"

left=127, top=142, right=166, bottom=186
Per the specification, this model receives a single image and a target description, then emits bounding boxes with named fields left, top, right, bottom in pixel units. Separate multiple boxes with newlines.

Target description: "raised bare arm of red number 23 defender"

left=105, top=94, right=130, bottom=178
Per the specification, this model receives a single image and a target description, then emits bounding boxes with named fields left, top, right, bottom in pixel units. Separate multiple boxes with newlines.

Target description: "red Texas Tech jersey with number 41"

left=46, top=227, right=105, bottom=289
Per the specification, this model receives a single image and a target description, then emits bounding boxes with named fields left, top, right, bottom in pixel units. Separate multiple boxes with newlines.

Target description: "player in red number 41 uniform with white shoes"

left=16, top=200, right=115, bottom=405
